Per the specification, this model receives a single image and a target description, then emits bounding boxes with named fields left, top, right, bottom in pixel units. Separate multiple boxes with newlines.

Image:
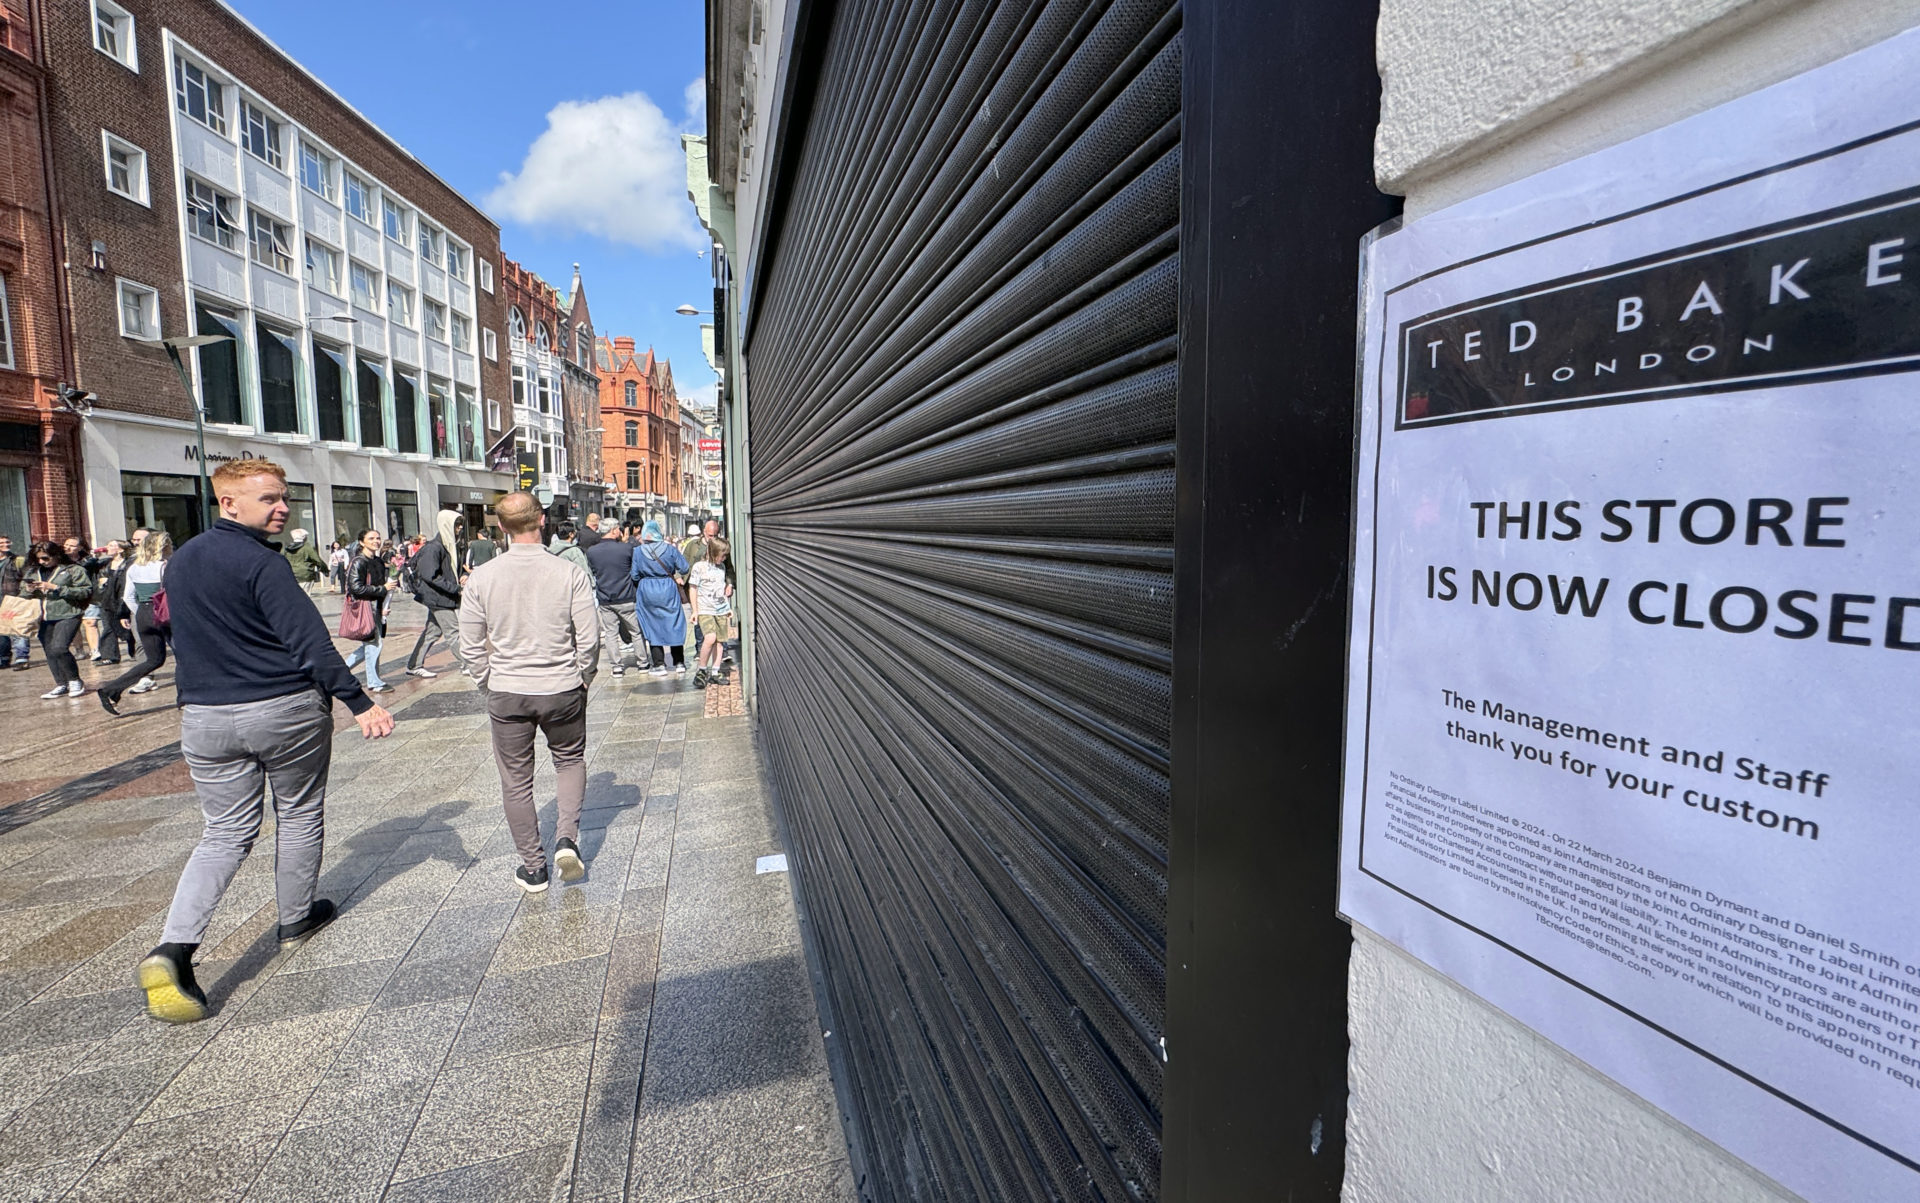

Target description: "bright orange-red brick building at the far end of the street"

left=597, top=336, right=687, bottom=522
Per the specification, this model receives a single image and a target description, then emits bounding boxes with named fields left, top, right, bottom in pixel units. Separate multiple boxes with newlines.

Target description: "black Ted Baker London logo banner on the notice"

left=1396, top=190, right=1920, bottom=428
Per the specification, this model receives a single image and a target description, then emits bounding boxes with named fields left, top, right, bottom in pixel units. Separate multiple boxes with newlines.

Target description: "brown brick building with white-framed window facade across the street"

left=44, top=0, right=513, bottom=543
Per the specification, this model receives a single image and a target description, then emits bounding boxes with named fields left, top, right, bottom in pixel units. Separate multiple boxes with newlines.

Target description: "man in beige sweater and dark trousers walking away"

left=461, top=493, right=599, bottom=894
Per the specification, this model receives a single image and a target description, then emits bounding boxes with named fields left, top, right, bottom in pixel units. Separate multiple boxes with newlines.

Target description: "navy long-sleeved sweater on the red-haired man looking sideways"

left=167, top=518, right=372, bottom=714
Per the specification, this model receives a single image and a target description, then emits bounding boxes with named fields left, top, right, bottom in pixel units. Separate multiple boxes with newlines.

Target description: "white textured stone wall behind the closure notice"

left=1344, top=0, right=1920, bottom=1203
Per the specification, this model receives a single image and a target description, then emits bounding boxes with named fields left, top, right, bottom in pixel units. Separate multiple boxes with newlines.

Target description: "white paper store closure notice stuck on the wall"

left=1340, top=33, right=1920, bottom=1203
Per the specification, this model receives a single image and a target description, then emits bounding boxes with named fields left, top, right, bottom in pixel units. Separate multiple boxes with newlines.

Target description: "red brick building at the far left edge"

left=0, top=0, right=84, bottom=551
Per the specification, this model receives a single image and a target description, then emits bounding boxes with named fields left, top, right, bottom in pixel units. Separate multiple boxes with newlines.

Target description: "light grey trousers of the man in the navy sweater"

left=161, top=691, right=334, bottom=944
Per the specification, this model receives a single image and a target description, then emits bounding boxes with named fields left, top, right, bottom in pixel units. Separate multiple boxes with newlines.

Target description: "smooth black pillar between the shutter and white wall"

left=1164, top=0, right=1398, bottom=1203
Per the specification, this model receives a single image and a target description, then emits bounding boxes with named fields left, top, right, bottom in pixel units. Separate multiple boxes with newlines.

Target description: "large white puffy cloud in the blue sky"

left=486, top=93, right=708, bottom=251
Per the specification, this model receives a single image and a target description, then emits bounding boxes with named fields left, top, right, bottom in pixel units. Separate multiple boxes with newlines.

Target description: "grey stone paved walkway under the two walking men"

left=0, top=673, right=854, bottom=1203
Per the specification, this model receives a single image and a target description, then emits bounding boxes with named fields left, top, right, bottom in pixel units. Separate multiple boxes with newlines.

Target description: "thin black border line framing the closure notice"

left=1359, top=121, right=1920, bottom=1172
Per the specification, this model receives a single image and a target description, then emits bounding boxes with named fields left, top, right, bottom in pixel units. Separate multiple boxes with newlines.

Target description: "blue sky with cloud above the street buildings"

left=228, top=0, right=714, bottom=397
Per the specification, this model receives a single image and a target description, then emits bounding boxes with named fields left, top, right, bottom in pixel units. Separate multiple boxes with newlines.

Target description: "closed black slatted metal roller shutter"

left=745, top=0, right=1181, bottom=1201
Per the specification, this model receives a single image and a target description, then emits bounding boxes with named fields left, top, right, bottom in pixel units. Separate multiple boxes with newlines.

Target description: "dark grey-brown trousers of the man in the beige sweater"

left=486, top=689, right=588, bottom=869
